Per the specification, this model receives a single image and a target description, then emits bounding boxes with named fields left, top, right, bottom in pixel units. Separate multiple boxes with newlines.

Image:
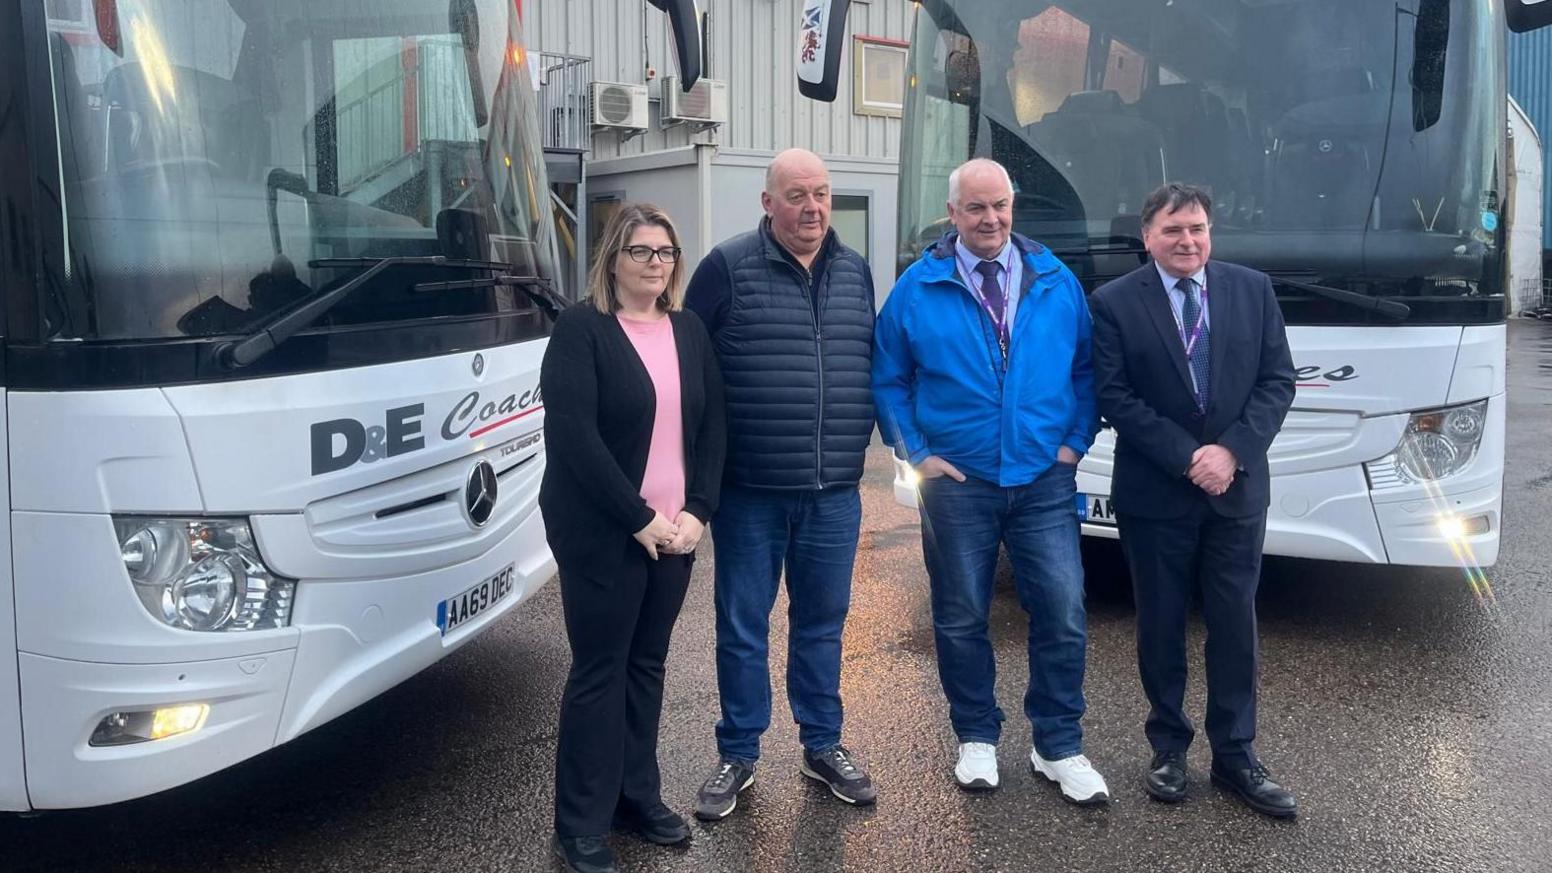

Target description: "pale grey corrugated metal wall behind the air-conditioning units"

left=523, top=0, right=916, bottom=160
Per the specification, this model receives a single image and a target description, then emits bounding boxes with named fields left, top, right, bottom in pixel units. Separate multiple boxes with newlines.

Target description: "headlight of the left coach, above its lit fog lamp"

left=113, top=516, right=296, bottom=631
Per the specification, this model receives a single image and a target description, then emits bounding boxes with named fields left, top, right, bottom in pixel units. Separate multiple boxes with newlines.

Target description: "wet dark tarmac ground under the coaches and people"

left=9, top=322, right=1552, bottom=873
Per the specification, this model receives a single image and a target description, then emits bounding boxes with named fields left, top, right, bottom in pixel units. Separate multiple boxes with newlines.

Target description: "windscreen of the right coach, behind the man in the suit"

left=900, top=0, right=1504, bottom=323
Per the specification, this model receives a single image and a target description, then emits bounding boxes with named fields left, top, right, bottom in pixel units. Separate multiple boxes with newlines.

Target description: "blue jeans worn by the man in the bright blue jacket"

left=920, top=463, right=1088, bottom=760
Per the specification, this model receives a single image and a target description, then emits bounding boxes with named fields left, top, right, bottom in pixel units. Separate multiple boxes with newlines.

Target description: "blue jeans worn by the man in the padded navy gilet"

left=711, top=485, right=863, bottom=764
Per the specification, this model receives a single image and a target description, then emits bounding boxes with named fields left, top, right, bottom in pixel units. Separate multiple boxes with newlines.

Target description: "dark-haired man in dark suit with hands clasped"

left=1090, top=183, right=1297, bottom=819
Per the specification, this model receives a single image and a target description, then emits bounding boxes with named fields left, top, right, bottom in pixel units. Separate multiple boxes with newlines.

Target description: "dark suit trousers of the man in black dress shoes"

left=1116, top=500, right=1266, bottom=767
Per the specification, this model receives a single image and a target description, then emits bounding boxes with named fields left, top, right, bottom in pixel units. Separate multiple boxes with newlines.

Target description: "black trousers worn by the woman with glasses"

left=556, top=539, right=695, bottom=837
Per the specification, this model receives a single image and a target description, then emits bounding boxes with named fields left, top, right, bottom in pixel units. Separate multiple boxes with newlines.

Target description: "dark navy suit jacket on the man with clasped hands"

left=1090, top=261, right=1294, bottom=519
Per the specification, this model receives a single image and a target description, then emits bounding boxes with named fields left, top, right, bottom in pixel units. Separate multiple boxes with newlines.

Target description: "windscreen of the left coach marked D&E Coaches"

left=39, top=0, right=556, bottom=340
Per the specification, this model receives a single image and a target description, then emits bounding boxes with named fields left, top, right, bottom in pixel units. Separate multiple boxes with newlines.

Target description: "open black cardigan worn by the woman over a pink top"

left=539, top=301, right=726, bottom=575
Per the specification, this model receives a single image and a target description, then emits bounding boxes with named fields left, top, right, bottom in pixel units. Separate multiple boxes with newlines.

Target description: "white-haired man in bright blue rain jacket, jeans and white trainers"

left=872, top=158, right=1110, bottom=805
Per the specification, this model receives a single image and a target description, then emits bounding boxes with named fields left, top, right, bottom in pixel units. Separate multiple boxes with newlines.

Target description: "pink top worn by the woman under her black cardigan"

left=616, top=315, right=684, bottom=522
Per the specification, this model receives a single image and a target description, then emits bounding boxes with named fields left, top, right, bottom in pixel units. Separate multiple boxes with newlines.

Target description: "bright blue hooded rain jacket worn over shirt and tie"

left=872, top=233, right=1099, bottom=488
